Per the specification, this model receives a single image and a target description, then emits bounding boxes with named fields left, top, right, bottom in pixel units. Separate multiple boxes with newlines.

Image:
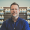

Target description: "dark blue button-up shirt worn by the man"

left=1, top=17, right=29, bottom=30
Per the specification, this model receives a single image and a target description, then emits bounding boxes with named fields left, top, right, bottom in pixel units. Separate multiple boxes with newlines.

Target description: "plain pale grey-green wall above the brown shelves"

left=0, top=0, right=30, bottom=7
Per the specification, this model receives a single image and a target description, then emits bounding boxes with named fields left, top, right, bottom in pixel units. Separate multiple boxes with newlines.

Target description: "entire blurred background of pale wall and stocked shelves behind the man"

left=0, top=0, right=30, bottom=28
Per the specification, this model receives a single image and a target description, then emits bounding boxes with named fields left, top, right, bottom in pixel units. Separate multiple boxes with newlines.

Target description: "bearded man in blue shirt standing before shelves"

left=1, top=3, right=29, bottom=30
